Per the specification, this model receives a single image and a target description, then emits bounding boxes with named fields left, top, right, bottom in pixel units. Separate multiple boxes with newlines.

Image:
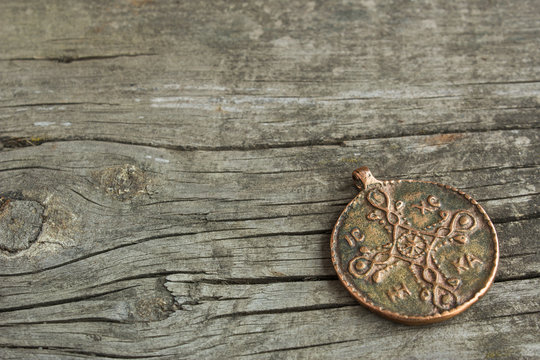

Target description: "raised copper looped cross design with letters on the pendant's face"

left=345, top=186, right=481, bottom=311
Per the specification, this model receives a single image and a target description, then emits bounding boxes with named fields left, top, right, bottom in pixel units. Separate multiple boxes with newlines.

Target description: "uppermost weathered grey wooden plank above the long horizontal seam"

left=0, top=0, right=540, bottom=149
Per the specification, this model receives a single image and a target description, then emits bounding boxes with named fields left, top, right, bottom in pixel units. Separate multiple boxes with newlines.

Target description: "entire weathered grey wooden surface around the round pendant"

left=0, top=0, right=540, bottom=359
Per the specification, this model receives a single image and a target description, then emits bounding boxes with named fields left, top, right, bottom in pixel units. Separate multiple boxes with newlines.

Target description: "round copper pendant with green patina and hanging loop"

left=330, top=167, right=499, bottom=324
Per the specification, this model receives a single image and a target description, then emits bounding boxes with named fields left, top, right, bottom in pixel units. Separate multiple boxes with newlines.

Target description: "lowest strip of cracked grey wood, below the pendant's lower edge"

left=0, top=275, right=540, bottom=359
